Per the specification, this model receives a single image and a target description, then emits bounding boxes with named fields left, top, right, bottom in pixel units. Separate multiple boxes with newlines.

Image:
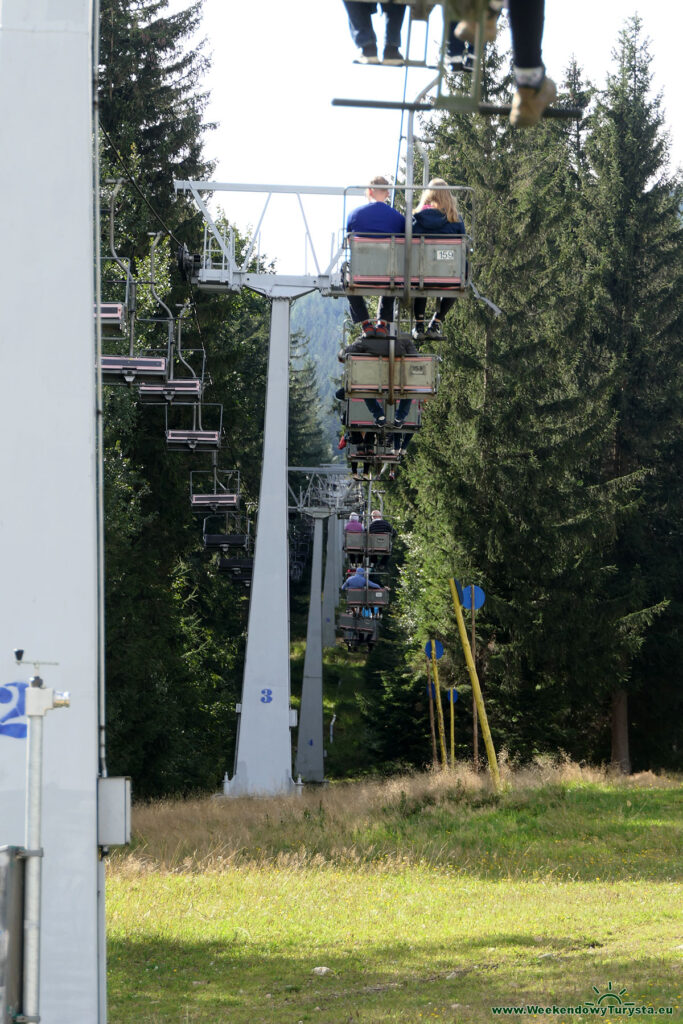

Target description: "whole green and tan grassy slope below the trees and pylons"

left=109, top=768, right=683, bottom=1024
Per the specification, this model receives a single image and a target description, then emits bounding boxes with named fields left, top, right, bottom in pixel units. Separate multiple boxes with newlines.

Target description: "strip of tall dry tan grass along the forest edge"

left=114, top=758, right=679, bottom=872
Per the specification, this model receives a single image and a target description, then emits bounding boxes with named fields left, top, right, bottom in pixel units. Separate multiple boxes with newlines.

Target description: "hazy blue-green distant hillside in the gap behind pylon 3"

left=292, top=292, right=348, bottom=453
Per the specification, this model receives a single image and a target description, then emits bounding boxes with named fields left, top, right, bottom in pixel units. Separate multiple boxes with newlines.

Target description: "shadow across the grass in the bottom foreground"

left=109, top=932, right=674, bottom=1024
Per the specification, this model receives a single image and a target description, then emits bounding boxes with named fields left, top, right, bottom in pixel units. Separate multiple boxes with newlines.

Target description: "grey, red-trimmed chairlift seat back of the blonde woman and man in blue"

left=343, top=233, right=469, bottom=295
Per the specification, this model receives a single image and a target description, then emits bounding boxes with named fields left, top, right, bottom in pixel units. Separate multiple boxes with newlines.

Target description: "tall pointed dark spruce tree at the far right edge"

left=584, top=16, right=683, bottom=771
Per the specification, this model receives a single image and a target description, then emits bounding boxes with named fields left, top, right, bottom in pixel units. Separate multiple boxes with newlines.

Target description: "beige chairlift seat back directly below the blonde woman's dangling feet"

left=344, top=354, right=438, bottom=398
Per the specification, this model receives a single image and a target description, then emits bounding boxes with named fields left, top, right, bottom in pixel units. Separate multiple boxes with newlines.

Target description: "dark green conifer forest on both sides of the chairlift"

left=99, top=0, right=683, bottom=798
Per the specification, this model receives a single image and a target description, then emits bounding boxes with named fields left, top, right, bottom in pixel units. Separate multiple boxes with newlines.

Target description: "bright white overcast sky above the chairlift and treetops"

left=171, top=0, right=683, bottom=272
